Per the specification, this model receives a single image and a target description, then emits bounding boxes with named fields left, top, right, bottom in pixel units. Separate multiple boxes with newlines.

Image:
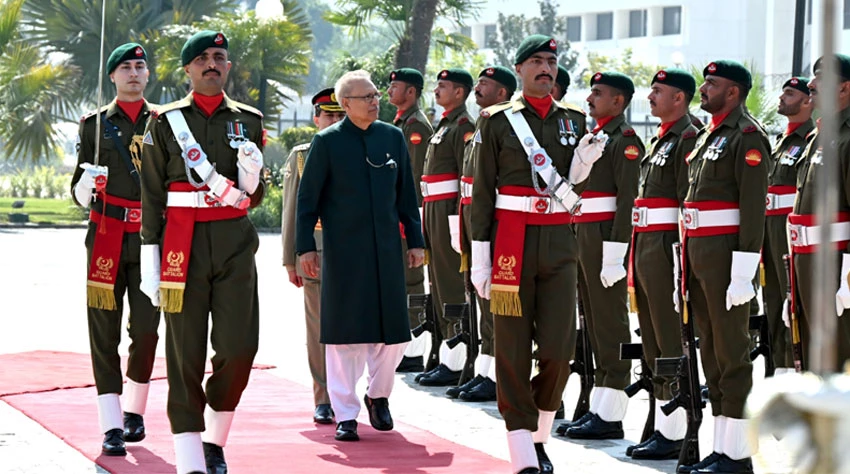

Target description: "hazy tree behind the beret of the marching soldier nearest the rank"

left=489, top=0, right=578, bottom=72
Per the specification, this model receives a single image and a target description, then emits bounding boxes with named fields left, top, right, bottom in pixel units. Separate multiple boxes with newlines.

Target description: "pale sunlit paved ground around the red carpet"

left=0, top=228, right=788, bottom=474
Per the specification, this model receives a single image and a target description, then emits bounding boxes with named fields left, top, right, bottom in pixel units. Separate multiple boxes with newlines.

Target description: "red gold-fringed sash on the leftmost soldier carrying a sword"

left=86, top=193, right=142, bottom=310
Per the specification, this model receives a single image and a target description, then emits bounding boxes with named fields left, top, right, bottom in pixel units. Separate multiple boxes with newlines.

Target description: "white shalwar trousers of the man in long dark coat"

left=325, top=342, right=407, bottom=422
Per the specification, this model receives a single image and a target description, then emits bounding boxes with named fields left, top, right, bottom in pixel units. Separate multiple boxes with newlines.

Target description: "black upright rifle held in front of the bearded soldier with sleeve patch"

left=655, top=243, right=705, bottom=466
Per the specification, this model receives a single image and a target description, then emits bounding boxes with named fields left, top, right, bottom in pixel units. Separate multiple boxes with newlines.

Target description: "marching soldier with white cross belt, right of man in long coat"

left=471, top=35, right=607, bottom=474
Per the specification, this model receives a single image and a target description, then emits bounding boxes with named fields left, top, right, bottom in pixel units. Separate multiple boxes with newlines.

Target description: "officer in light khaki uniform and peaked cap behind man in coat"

left=281, top=87, right=345, bottom=424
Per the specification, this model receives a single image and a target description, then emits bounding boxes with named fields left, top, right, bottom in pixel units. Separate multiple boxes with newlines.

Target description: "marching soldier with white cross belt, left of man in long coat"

left=141, top=30, right=265, bottom=474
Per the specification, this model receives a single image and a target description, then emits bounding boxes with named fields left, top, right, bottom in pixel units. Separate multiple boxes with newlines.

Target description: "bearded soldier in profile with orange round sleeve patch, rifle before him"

left=676, top=60, right=770, bottom=473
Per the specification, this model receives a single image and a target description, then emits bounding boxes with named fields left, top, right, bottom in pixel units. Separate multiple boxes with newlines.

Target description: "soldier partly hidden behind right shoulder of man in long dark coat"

left=387, top=68, right=434, bottom=372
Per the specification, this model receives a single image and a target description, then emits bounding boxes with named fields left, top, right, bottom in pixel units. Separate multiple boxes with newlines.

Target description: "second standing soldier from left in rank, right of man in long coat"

left=416, top=68, right=475, bottom=387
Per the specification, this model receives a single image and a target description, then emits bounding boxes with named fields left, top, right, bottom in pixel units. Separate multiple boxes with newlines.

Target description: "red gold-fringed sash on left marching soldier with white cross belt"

left=159, top=182, right=248, bottom=313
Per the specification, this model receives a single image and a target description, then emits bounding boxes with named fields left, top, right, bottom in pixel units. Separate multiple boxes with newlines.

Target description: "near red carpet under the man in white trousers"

left=2, top=370, right=510, bottom=474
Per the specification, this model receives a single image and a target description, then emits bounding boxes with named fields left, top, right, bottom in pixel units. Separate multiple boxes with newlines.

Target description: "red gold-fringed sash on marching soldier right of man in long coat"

left=490, top=186, right=572, bottom=316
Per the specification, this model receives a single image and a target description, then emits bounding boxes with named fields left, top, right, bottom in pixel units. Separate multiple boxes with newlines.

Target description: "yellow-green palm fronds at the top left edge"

left=0, top=0, right=75, bottom=161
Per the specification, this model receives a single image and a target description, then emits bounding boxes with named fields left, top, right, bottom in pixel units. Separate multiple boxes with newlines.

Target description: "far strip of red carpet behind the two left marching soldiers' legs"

left=0, top=351, right=272, bottom=397
